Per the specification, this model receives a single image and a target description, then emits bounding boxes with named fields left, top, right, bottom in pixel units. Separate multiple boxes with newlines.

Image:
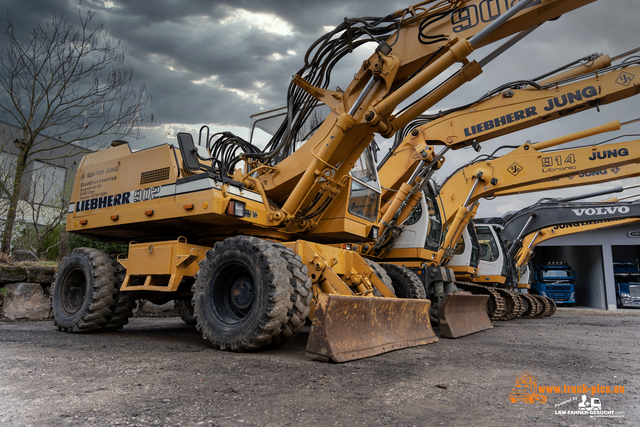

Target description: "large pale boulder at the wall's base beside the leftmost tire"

left=3, top=283, right=51, bottom=320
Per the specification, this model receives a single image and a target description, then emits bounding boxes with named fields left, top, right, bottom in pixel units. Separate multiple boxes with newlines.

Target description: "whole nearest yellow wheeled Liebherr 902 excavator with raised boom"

left=52, top=0, right=593, bottom=362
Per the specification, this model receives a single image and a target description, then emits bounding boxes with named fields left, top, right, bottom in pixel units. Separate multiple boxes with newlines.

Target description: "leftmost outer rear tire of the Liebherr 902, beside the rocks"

left=51, top=248, right=116, bottom=332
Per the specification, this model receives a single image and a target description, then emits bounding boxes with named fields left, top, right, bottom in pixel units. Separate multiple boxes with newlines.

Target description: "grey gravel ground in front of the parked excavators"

left=0, top=309, right=640, bottom=426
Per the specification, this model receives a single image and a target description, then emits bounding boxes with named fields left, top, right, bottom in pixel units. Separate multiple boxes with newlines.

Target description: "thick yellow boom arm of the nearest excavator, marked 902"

left=250, top=0, right=594, bottom=228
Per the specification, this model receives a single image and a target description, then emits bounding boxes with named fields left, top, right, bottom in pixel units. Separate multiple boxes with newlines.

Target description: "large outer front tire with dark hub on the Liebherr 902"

left=193, top=236, right=293, bottom=351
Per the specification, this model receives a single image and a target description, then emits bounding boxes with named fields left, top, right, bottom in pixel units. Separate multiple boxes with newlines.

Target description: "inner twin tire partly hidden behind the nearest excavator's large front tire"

left=271, top=243, right=313, bottom=346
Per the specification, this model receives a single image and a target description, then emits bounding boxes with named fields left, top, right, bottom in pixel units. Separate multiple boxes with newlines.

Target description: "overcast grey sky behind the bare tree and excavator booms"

left=0, top=0, right=640, bottom=216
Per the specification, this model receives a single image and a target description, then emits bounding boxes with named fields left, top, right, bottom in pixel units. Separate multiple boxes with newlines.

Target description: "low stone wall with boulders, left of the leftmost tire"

left=0, top=265, right=56, bottom=320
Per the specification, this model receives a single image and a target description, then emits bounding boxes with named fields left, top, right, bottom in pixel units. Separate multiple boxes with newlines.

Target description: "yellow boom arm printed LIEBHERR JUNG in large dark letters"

left=379, top=55, right=640, bottom=200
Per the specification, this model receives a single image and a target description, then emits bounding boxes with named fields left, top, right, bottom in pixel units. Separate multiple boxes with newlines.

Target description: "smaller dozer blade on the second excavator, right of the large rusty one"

left=438, top=293, right=493, bottom=338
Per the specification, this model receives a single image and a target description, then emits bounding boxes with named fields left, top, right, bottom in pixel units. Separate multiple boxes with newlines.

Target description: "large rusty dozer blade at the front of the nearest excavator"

left=307, top=293, right=438, bottom=363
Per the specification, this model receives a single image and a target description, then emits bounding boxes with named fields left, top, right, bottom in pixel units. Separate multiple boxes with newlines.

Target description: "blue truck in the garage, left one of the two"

left=531, top=262, right=576, bottom=305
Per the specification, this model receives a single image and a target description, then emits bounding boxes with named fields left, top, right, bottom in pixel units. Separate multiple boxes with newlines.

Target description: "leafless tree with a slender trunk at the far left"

left=0, top=12, right=153, bottom=252
